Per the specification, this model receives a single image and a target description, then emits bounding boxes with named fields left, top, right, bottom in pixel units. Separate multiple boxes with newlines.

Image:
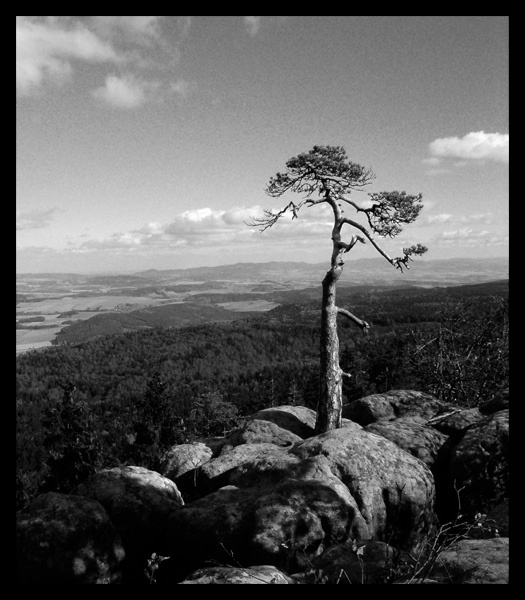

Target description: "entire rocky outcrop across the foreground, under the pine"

left=17, top=390, right=509, bottom=584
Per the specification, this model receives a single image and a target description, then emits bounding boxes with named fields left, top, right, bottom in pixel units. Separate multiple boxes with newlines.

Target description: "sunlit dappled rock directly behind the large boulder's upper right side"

left=365, top=417, right=448, bottom=470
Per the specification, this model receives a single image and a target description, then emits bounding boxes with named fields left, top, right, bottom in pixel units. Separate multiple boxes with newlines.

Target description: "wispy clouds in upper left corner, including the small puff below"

left=16, top=16, right=191, bottom=102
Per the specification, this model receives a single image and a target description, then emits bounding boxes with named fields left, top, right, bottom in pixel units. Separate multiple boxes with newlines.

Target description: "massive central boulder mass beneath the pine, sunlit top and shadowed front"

left=163, top=423, right=435, bottom=573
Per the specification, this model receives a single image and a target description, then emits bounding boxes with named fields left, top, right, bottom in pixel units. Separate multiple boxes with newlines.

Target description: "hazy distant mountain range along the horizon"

left=17, top=258, right=509, bottom=292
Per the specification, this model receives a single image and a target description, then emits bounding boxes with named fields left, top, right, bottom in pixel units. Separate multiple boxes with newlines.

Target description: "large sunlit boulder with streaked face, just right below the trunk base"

left=290, top=424, right=435, bottom=549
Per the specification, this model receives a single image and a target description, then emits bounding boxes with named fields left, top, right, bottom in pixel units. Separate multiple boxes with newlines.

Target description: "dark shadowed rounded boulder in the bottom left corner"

left=16, top=492, right=125, bottom=584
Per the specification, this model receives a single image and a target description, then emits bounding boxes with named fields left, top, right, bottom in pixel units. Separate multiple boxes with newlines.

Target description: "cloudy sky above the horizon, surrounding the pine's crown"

left=16, top=16, right=509, bottom=273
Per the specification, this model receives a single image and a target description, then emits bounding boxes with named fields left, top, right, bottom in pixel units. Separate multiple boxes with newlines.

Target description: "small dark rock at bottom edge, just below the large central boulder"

left=304, top=540, right=398, bottom=584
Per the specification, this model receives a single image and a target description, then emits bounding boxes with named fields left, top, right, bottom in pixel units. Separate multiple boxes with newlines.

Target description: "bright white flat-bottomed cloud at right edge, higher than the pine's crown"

left=423, top=131, right=509, bottom=166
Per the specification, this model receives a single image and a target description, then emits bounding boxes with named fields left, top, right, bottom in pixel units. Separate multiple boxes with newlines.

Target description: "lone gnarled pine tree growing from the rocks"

left=249, top=146, right=427, bottom=433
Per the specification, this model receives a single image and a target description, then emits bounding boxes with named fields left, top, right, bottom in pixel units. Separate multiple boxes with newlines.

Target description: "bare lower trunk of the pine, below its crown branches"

left=315, top=257, right=343, bottom=434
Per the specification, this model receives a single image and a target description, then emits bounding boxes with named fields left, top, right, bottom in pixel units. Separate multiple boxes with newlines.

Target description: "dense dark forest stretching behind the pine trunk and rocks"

left=16, top=281, right=509, bottom=508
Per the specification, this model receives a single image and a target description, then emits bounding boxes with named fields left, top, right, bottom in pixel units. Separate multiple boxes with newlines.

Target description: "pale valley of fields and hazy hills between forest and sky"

left=16, top=258, right=509, bottom=354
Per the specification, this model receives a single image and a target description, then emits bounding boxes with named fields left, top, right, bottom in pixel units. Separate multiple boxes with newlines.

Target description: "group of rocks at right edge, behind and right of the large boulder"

left=344, top=390, right=509, bottom=521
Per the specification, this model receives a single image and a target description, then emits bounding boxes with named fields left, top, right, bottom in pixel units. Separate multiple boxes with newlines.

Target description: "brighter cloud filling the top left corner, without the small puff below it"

left=16, top=17, right=118, bottom=95
